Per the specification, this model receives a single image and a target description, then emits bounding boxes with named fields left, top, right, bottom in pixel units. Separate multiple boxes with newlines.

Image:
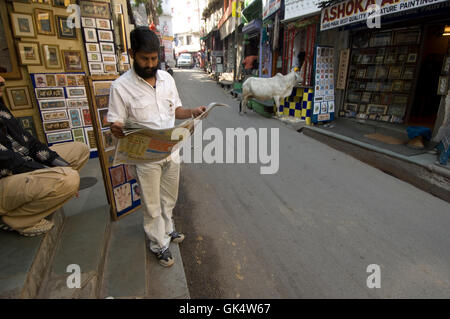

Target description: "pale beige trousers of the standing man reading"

left=136, top=160, right=180, bottom=252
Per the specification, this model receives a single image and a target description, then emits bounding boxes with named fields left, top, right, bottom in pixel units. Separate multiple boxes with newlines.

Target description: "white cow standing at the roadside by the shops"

left=239, top=67, right=303, bottom=116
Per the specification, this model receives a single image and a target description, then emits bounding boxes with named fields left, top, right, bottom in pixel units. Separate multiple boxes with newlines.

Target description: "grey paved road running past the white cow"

left=174, top=70, right=450, bottom=298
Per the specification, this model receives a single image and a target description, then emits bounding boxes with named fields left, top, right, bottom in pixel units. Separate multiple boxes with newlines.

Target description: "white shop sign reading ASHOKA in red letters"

left=320, top=0, right=447, bottom=31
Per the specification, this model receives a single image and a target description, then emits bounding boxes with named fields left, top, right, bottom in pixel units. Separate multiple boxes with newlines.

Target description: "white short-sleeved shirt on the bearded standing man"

left=107, top=68, right=182, bottom=129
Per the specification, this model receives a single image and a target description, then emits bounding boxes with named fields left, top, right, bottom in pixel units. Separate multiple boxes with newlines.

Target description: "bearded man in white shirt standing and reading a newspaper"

left=107, top=27, right=206, bottom=267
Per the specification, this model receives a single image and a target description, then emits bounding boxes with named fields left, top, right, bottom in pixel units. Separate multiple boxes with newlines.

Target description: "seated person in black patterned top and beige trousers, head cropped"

left=0, top=77, right=89, bottom=236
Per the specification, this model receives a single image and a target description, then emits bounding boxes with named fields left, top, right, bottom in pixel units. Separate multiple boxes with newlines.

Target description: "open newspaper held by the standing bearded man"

left=113, top=102, right=229, bottom=166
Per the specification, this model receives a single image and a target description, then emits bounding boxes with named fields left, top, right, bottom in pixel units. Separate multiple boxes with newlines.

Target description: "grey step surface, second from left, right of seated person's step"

left=39, top=206, right=110, bottom=299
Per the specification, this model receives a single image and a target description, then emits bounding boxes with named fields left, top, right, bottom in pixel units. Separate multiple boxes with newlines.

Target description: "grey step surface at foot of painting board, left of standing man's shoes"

left=100, top=211, right=147, bottom=299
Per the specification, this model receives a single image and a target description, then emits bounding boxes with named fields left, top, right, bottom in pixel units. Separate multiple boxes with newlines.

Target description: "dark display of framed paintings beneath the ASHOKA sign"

left=344, top=29, right=420, bottom=123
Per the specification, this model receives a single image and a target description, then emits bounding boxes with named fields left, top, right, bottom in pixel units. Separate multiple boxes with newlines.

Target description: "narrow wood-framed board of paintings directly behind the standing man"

left=86, top=75, right=141, bottom=220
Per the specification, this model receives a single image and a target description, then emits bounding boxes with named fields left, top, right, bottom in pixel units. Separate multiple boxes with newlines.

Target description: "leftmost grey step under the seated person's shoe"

left=0, top=209, right=64, bottom=299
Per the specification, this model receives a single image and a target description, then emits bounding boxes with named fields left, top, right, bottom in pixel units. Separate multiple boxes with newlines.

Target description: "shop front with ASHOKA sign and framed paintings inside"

left=321, top=1, right=450, bottom=138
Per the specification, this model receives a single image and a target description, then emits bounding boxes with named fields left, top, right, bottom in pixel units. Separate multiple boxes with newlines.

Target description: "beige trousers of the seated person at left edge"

left=0, top=142, right=89, bottom=229
